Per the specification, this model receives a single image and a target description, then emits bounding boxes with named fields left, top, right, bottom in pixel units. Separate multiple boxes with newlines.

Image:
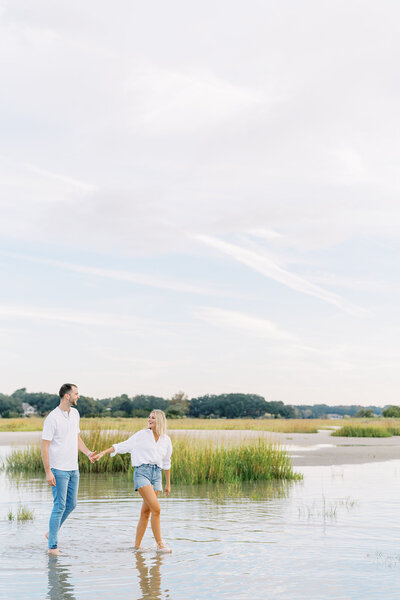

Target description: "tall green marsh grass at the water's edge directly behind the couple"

left=5, top=430, right=302, bottom=485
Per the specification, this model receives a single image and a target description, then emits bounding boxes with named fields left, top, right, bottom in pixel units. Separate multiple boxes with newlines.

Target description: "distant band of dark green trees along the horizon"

left=0, top=388, right=400, bottom=419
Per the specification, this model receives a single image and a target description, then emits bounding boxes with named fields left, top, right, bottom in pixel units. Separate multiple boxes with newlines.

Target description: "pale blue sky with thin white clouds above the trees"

left=0, top=0, right=400, bottom=406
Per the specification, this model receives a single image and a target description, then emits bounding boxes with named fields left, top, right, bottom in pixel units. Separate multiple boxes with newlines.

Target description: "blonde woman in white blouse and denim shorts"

left=96, top=410, right=172, bottom=552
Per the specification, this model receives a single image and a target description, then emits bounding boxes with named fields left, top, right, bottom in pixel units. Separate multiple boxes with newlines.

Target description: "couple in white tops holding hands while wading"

left=42, top=383, right=172, bottom=555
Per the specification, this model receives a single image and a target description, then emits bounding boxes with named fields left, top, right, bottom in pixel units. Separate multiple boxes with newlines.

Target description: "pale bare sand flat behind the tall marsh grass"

left=0, top=429, right=400, bottom=467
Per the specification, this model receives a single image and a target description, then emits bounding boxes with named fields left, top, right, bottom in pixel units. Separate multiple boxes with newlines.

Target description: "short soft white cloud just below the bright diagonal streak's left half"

left=194, top=306, right=296, bottom=342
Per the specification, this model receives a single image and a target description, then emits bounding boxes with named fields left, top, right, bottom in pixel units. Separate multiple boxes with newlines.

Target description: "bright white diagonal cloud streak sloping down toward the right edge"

left=193, top=234, right=369, bottom=316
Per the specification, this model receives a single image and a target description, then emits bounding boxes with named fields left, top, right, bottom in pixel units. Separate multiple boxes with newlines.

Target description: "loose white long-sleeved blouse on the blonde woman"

left=110, top=429, right=172, bottom=471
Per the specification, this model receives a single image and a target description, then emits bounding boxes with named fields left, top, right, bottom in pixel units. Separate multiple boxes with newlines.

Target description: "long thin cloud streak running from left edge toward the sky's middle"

left=0, top=252, right=231, bottom=296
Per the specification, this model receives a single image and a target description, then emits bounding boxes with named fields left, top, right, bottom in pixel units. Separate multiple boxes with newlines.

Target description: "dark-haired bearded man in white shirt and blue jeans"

left=42, top=383, right=96, bottom=554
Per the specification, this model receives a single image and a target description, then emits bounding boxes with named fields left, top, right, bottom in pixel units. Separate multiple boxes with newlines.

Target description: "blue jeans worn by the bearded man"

left=49, top=469, right=79, bottom=549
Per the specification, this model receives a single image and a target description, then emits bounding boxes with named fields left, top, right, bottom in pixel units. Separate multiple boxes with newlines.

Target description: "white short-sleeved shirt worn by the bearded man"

left=42, top=406, right=80, bottom=471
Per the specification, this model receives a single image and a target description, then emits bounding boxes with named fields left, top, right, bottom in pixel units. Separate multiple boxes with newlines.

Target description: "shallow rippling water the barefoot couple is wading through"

left=0, top=442, right=400, bottom=600
